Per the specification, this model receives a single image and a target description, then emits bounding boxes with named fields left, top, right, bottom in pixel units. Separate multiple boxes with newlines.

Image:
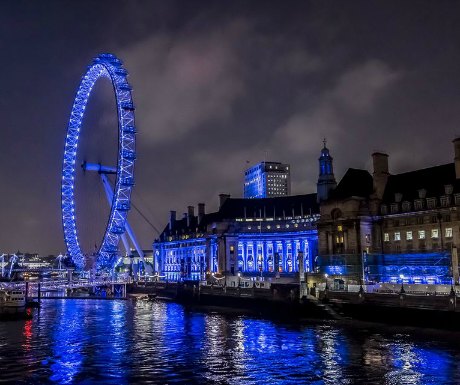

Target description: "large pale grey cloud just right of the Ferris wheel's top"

left=120, top=18, right=247, bottom=145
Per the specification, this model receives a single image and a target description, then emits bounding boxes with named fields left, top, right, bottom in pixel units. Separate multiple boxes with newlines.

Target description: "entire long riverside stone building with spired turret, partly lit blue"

left=153, top=139, right=460, bottom=287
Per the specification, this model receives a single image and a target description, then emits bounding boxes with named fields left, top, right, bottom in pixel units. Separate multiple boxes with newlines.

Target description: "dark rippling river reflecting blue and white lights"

left=0, top=300, right=460, bottom=385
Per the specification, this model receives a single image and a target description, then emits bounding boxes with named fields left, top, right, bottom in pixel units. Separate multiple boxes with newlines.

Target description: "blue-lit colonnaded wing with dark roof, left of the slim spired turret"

left=153, top=194, right=319, bottom=281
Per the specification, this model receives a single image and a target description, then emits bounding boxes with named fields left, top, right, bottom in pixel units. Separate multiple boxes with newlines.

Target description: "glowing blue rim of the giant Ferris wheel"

left=61, top=54, right=136, bottom=268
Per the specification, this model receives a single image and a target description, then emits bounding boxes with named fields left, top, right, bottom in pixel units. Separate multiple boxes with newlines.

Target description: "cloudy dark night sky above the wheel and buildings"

left=0, top=0, right=460, bottom=254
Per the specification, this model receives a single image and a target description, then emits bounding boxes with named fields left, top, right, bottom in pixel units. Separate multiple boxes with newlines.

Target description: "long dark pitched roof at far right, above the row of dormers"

left=383, top=163, right=460, bottom=203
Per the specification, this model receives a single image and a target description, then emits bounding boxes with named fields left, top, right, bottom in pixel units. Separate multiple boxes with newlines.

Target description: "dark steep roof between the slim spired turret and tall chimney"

left=330, top=168, right=373, bottom=199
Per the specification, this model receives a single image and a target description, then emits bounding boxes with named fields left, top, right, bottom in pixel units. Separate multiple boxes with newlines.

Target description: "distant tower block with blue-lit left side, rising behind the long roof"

left=244, top=162, right=291, bottom=198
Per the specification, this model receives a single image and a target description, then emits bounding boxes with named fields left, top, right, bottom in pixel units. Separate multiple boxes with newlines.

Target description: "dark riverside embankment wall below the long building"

left=128, top=282, right=460, bottom=330
